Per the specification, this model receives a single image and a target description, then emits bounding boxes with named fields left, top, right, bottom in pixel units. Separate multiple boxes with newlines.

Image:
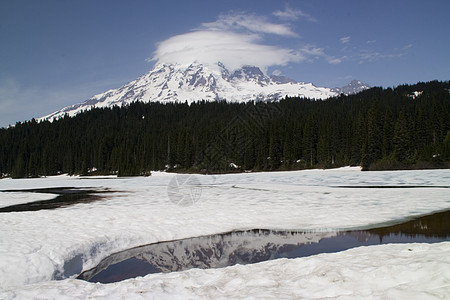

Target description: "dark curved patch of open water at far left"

left=0, top=187, right=107, bottom=213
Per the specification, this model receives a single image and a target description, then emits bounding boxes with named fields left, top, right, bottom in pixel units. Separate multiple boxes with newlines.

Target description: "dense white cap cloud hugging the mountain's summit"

left=152, top=30, right=303, bottom=70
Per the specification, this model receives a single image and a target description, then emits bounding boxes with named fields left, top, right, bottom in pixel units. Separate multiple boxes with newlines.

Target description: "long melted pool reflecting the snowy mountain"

left=78, top=210, right=450, bottom=283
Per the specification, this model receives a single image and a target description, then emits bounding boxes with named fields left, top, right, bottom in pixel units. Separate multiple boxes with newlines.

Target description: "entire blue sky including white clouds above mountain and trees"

left=0, top=0, right=450, bottom=127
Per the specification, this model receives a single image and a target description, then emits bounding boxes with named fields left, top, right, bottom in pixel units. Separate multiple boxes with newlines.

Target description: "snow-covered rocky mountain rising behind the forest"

left=41, top=63, right=370, bottom=121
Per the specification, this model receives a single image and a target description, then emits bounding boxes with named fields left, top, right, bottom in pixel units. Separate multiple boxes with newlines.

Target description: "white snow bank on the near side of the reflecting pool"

left=0, top=242, right=450, bottom=299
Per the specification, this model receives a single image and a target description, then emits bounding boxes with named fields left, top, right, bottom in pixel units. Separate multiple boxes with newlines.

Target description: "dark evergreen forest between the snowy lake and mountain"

left=0, top=81, right=450, bottom=178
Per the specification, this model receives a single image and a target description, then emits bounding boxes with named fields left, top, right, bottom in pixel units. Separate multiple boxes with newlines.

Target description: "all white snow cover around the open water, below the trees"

left=0, top=168, right=450, bottom=299
